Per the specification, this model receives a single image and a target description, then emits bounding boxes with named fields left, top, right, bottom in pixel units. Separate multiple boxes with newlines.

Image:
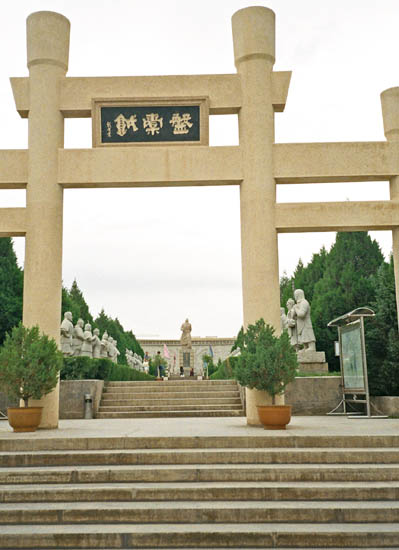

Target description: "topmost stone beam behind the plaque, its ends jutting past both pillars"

left=10, top=71, right=291, bottom=118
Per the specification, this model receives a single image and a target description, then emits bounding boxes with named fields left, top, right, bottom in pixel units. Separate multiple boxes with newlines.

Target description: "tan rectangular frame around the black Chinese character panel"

left=91, top=96, right=209, bottom=147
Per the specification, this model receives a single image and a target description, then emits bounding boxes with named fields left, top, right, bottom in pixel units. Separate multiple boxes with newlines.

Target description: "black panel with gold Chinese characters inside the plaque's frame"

left=100, top=105, right=200, bottom=143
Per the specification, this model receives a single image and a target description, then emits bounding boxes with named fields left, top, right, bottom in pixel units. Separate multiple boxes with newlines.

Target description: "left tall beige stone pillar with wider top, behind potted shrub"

left=23, top=11, right=70, bottom=428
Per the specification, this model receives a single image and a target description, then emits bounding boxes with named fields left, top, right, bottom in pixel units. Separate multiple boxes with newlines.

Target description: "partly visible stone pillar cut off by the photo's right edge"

left=381, top=88, right=399, bottom=332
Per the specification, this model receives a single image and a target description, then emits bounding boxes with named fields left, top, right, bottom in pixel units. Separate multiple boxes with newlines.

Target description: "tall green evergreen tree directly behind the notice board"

left=312, top=231, right=384, bottom=370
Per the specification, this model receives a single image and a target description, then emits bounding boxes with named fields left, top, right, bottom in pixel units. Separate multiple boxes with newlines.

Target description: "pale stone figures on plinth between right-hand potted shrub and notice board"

left=280, top=288, right=316, bottom=351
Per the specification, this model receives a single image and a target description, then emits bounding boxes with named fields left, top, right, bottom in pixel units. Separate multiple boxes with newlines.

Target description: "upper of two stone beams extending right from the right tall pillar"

left=274, top=141, right=399, bottom=183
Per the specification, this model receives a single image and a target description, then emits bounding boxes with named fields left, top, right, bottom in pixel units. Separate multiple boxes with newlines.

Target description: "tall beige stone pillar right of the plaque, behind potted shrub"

left=232, top=7, right=280, bottom=425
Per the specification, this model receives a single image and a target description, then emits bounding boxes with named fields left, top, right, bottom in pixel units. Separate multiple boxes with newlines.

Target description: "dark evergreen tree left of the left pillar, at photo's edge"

left=0, top=237, right=23, bottom=344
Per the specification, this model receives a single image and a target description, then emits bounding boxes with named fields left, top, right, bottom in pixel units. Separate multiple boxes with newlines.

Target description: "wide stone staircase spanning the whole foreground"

left=0, top=434, right=399, bottom=550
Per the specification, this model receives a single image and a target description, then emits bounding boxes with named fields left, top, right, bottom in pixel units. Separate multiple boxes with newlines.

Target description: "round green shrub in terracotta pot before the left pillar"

left=0, top=324, right=63, bottom=432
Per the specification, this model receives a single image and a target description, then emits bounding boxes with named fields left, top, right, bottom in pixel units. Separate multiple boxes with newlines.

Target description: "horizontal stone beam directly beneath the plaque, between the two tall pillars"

left=58, top=146, right=243, bottom=188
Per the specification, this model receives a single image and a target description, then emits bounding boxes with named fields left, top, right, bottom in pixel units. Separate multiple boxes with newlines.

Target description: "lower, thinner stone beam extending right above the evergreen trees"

left=276, top=201, right=399, bottom=233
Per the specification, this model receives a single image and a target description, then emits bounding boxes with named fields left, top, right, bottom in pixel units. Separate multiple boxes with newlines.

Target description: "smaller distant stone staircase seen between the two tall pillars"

left=96, top=380, right=244, bottom=418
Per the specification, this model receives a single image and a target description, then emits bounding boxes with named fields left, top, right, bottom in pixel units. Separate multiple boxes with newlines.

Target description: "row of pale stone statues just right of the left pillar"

left=60, top=311, right=120, bottom=363
